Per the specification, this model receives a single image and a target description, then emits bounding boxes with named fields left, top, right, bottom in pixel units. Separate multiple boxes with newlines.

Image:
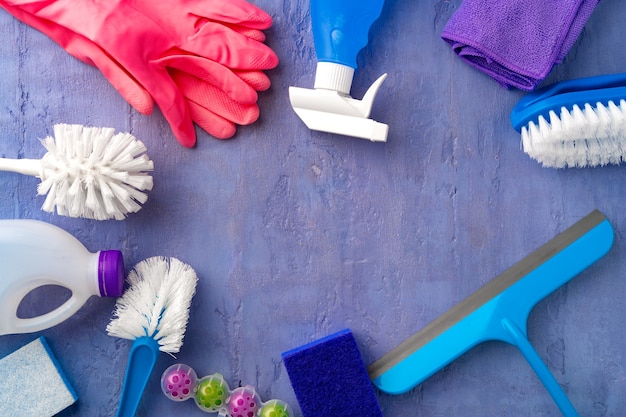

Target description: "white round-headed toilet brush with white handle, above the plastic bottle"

left=0, top=124, right=154, bottom=220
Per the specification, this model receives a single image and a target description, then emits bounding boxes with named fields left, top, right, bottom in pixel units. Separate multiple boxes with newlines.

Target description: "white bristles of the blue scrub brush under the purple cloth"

left=521, top=100, right=626, bottom=168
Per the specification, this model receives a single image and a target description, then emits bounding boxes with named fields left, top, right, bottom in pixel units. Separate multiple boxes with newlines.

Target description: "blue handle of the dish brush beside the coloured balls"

left=117, top=336, right=159, bottom=417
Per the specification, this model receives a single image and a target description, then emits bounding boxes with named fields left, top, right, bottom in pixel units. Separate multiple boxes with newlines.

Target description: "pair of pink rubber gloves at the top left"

left=0, top=0, right=278, bottom=147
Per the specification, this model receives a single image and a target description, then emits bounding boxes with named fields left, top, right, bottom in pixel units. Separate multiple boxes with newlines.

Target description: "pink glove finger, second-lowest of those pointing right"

left=170, top=70, right=259, bottom=125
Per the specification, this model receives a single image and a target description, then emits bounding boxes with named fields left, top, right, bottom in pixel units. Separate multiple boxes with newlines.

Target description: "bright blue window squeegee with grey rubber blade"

left=368, top=210, right=614, bottom=417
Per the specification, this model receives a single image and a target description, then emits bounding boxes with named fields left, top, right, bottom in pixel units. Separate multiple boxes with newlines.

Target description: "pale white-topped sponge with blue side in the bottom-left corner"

left=0, top=337, right=78, bottom=417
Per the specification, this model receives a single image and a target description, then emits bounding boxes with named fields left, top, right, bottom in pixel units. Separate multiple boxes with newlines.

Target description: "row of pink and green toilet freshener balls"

left=161, top=363, right=294, bottom=417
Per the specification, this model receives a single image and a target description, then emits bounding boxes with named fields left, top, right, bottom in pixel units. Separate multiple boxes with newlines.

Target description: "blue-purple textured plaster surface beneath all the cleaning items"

left=0, top=0, right=626, bottom=417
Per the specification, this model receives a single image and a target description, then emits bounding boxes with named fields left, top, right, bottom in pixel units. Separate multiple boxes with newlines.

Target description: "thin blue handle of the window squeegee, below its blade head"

left=502, top=319, right=578, bottom=417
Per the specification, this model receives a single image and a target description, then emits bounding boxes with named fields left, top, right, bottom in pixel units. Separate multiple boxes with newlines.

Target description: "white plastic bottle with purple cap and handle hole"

left=0, top=219, right=124, bottom=335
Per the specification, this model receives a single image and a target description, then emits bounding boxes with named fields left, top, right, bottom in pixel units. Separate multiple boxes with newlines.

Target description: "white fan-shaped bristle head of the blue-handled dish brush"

left=106, top=256, right=198, bottom=354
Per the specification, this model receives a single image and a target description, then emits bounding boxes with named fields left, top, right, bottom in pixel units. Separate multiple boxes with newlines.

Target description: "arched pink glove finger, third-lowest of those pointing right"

left=158, top=55, right=259, bottom=104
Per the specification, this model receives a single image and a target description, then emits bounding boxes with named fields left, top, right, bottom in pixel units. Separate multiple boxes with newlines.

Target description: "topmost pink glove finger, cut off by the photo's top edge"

left=186, top=0, right=272, bottom=30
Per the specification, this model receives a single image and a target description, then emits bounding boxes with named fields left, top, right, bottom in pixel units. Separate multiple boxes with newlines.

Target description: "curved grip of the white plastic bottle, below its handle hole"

left=0, top=292, right=86, bottom=335
